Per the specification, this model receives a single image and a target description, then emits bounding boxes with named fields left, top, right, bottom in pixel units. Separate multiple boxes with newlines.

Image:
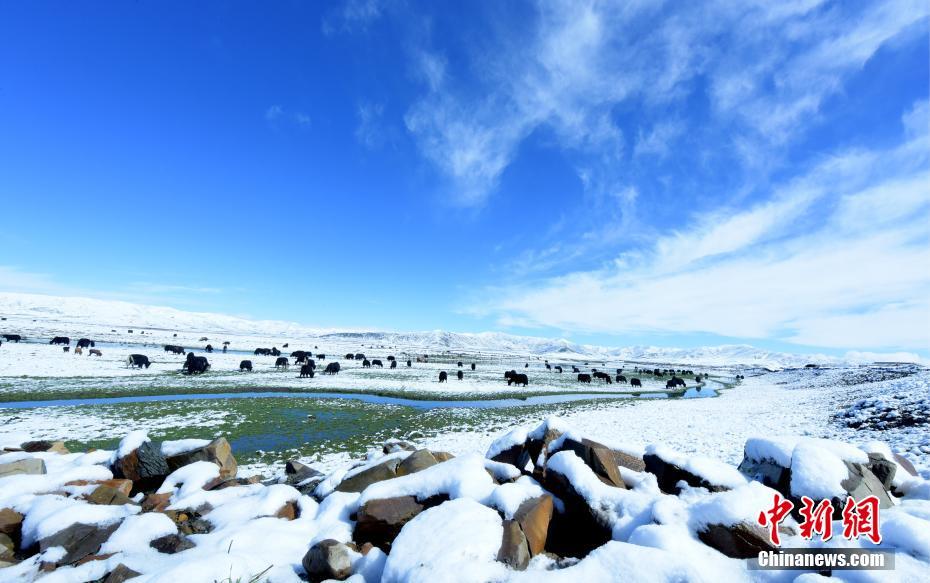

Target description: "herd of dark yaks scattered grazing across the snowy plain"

left=0, top=334, right=712, bottom=389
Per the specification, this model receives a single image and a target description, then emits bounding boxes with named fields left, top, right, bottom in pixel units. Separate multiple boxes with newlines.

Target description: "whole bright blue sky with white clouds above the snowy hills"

left=0, top=0, right=930, bottom=355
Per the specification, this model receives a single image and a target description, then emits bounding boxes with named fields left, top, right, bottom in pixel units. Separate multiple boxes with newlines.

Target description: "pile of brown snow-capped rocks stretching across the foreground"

left=0, top=419, right=930, bottom=583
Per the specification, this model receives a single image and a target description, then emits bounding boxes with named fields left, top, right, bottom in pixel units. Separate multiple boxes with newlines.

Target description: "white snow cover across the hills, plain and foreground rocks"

left=0, top=294, right=930, bottom=581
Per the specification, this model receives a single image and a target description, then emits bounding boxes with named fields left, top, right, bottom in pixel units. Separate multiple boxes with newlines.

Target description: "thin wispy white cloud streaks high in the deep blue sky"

left=406, top=0, right=928, bottom=206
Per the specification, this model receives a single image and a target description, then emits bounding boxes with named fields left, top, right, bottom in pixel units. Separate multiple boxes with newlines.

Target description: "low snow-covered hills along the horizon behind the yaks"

left=0, top=292, right=918, bottom=368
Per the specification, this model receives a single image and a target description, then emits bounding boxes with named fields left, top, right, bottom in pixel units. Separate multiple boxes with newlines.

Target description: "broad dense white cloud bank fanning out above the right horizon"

left=485, top=138, right=930, bottom=350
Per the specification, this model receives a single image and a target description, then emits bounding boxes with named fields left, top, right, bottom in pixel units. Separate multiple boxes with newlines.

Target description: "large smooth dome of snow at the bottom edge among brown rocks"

left=382, top=498, right=507, bottom=583
